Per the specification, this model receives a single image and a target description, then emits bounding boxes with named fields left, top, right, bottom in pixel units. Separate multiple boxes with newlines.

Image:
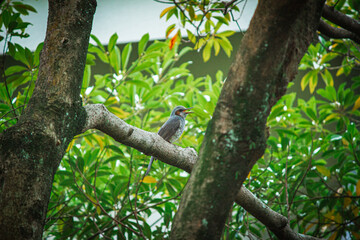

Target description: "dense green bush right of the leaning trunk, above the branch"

left=247, top=79, right=360, bottom=238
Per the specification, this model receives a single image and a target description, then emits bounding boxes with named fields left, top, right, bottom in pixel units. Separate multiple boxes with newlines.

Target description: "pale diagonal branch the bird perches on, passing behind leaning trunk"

left=82, top=104, right=318, bottom=240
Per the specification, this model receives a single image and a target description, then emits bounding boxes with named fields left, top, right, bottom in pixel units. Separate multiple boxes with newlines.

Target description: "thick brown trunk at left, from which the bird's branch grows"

left=0, top=0, right=96, bottom=240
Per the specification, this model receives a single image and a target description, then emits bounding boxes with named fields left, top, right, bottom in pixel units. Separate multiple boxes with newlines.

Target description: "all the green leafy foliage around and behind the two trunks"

left=0, top=1, right=360, bottom=239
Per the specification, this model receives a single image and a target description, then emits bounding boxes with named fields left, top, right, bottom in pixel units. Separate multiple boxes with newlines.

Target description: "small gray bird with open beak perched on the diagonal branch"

left=144, top=106, right=192, bottom=176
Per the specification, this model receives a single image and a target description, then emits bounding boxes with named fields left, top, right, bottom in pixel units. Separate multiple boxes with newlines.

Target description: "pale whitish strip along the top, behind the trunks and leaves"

left=0, top=0, right=257, bottom=50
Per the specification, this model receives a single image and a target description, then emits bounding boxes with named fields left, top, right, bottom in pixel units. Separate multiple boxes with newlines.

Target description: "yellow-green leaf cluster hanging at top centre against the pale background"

left=160, top=0, right=240, bottom=62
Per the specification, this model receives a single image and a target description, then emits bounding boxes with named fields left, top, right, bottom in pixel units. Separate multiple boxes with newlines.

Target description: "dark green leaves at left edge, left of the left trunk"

left=0, top=1, right=42, bottom=131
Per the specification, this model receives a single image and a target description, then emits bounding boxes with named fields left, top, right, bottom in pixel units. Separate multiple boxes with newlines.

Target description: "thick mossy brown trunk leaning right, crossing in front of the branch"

left=170, top=0, right=323, bottom=240
